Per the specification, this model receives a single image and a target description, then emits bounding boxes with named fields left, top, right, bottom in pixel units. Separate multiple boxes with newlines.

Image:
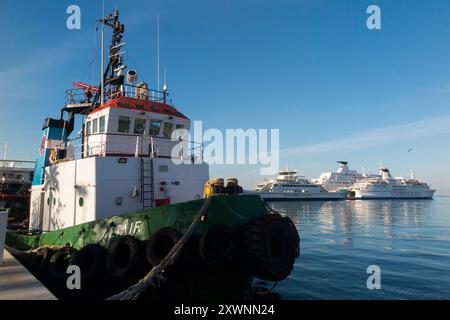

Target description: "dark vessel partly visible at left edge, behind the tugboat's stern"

left=0, top=157, right=35, bottom=228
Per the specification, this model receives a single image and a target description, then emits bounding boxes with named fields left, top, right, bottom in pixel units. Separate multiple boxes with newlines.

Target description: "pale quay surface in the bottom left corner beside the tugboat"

left=0, top=249, right=56, bottom=300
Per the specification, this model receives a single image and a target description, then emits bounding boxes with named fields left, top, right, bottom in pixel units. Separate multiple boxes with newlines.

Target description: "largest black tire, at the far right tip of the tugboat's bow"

left=243, top=214, right=297, bottom=281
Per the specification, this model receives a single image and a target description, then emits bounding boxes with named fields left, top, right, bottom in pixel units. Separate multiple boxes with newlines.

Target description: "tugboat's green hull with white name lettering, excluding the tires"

left=6, top=195, right=269, bottom=299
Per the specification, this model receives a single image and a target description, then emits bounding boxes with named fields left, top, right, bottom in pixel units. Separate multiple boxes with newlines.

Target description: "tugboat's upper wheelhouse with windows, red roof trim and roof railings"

left=53, top=83, right=202, bottom=162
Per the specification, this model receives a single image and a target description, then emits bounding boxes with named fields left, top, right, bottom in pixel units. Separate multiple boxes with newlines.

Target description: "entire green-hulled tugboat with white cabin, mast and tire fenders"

left=6, top=10, right=300, bottom=299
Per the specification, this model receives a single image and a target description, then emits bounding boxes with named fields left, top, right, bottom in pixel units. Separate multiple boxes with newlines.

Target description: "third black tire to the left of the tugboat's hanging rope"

left=70, top=243, right=106, bottom=282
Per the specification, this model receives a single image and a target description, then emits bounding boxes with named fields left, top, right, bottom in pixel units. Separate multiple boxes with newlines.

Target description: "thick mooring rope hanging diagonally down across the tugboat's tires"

left=107, top=196, right=214, bottom=300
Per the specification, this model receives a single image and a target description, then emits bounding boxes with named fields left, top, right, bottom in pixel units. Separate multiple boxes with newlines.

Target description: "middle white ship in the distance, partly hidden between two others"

left=311, top=161, right=364, bottom=191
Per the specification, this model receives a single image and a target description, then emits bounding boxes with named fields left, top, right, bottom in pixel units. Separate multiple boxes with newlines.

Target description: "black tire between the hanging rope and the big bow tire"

left=199, top=224, right=238, bottom=265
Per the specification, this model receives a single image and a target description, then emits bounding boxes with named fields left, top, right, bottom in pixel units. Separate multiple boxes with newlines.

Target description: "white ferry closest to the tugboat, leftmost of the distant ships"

left=255, top=169, right=348, bottom=201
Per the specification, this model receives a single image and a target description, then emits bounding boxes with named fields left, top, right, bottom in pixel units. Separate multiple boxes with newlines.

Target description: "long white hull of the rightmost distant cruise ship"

left=350, top=185, right=435, bottom=199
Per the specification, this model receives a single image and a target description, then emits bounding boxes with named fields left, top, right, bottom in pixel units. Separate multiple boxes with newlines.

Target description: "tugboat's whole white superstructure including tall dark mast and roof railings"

left=30, top=10, right=209, bottom=232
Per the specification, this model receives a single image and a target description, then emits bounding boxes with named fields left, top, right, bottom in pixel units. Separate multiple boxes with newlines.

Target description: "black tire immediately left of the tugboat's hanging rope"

left=145, top=227, right=181, bottom=266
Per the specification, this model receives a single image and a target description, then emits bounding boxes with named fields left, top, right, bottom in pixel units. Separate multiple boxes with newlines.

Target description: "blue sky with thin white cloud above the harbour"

left=0, top=0, right=450, bottom=195
